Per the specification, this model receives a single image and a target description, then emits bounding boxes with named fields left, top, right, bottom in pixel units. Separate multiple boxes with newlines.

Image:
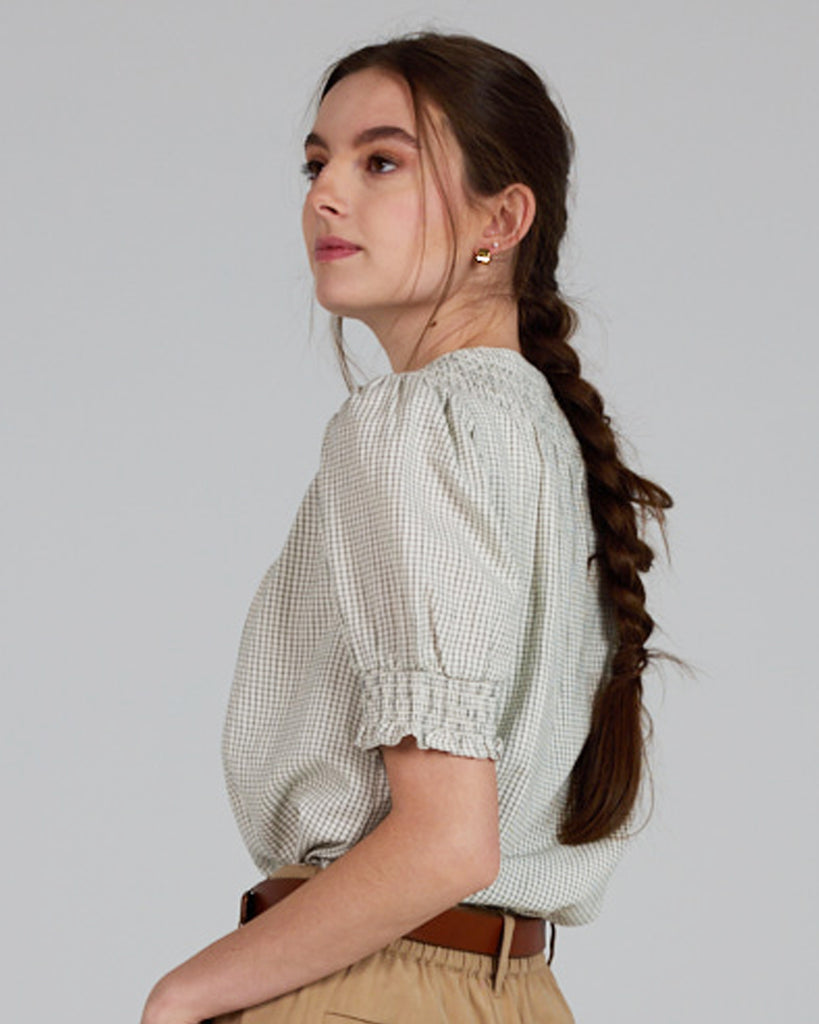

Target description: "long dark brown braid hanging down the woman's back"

left=519, top=286, right=673, bottom=844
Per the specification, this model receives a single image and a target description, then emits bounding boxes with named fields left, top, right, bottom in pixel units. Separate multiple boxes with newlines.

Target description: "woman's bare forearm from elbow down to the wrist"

left=142, top=812, right=492, bottom=1024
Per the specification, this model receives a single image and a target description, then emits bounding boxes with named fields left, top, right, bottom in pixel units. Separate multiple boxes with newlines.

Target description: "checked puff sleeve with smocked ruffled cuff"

left=317, top=374, right=521, bottom=760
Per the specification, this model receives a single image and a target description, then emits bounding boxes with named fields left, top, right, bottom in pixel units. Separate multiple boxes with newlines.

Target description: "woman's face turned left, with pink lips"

left=302, top=69, right=475, bottom=327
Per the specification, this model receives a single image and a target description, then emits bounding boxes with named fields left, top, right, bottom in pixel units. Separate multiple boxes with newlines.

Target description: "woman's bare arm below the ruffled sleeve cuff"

left=142, top=736, right=500, bottom=1024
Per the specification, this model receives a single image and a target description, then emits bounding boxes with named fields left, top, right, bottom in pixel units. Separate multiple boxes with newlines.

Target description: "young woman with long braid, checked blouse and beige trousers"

left=142, top=33, right=672, bottom=1024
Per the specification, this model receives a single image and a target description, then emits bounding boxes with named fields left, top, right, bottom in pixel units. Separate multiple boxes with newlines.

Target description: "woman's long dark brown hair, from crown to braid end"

left=319, top=32, right=680, bottom=845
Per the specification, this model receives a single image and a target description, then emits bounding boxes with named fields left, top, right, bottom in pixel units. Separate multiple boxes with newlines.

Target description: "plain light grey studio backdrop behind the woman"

left=0, top=0, right=819, bottom=1024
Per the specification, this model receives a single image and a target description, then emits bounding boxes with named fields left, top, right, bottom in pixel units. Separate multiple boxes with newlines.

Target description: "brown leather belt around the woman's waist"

left=240, top=878, right=555, bottom=963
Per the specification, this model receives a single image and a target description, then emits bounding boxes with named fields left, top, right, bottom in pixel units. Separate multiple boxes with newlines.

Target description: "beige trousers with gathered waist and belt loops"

left=214, top=864, right=574, bottom=1024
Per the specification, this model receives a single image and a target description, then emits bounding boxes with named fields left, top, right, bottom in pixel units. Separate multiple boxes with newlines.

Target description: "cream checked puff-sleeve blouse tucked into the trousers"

left=222, top=346, right=624, bottom=925
